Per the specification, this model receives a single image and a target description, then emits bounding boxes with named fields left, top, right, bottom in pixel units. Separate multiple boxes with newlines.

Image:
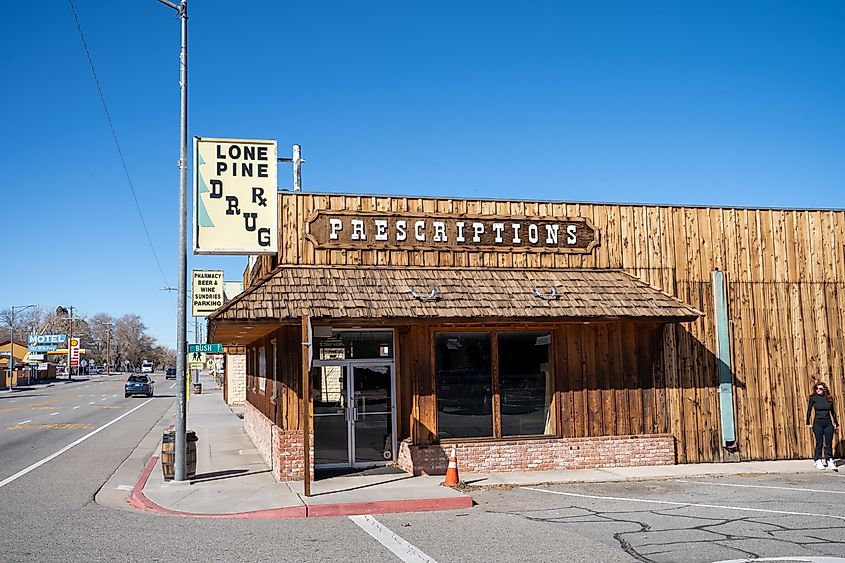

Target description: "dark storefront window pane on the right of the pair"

left=499, top=332, right=553, bottom=436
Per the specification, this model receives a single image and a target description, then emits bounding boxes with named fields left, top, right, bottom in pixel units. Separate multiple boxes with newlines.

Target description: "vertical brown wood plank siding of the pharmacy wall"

left=245, top=193, right=845, bottom=462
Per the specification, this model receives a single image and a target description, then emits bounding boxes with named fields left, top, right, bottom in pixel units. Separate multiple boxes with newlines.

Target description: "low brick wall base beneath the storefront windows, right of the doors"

left=397, top=434, right=675, bottom=475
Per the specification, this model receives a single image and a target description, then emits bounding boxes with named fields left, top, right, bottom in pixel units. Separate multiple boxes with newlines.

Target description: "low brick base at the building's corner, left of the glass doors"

left=244, top=402, right=314, bottom=481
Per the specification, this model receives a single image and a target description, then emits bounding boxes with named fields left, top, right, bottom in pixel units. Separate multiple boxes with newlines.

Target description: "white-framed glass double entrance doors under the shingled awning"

left=311, top=362, right=396, bottom=468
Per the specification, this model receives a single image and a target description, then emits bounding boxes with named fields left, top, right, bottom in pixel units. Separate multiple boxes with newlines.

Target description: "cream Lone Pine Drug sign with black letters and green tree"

left=194, top=137, right=278, bottom=254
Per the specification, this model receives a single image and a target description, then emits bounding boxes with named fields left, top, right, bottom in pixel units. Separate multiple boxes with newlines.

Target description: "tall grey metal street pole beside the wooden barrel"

left=158, top=0, right=188, bottom=481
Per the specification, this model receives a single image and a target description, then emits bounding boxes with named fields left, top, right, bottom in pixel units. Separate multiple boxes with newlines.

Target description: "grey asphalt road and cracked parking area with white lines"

left=0, top=375, right=845, bottom=562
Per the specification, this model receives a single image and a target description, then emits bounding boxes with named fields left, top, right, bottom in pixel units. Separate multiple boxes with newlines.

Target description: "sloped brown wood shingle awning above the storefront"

left=208, top=266, right=703, bottom=344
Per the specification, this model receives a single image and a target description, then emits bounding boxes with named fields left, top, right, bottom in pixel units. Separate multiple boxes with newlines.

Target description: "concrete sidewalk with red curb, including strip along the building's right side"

left=115, top=386, right=815, bottom=518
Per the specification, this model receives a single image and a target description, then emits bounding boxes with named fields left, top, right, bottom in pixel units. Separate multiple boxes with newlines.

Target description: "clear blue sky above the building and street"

left=0, top=0, right=845, bottom=346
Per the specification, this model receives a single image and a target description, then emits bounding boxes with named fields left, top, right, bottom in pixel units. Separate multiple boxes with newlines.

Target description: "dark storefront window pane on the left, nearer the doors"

left=435, top=332, right=493, bottom=438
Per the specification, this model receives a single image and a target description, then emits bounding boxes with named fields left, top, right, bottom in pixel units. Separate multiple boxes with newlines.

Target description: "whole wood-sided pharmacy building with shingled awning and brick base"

left=210, top=192, right=845, bottom=480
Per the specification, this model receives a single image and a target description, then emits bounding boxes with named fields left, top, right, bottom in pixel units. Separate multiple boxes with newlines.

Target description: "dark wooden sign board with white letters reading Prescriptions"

left=305, top=210, right=599, bottom=254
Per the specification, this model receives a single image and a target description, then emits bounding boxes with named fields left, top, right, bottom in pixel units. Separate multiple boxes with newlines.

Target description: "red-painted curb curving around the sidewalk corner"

left=129, top=456, right=474, bottom=519
